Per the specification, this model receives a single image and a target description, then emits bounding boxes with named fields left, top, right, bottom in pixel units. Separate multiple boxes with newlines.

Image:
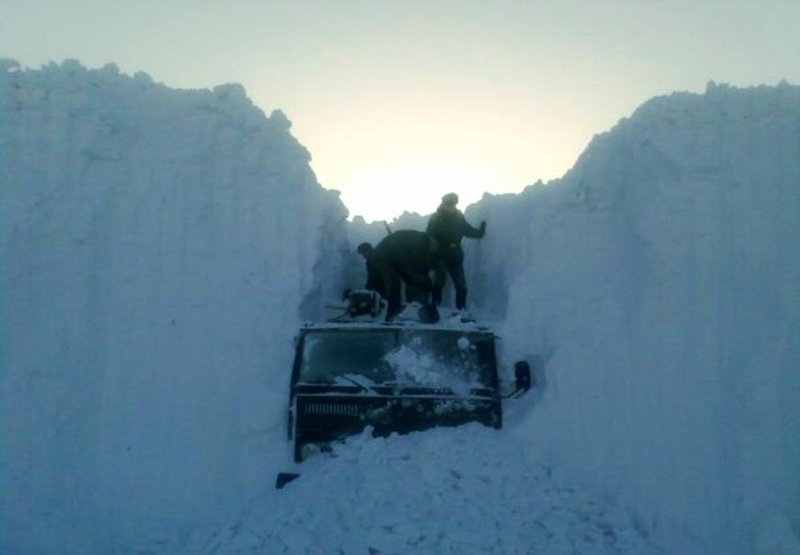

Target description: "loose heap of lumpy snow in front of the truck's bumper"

left=198, top=424, right=658, bottom=555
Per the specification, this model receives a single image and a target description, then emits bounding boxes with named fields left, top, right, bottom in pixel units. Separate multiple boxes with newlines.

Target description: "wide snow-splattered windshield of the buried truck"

left=299, top=329, right=495, bottom=393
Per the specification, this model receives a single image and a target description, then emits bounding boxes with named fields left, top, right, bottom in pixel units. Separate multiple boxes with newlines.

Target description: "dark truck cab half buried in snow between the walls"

left=288, top=322, right=503, bottom=462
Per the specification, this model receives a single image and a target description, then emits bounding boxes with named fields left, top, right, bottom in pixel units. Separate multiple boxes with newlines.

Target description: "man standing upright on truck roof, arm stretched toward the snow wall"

left=428, top=193, right=486, bottom=310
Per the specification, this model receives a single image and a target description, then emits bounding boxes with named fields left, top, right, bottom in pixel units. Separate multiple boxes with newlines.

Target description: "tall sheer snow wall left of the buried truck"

left=0, top=61, right=346, bottom=552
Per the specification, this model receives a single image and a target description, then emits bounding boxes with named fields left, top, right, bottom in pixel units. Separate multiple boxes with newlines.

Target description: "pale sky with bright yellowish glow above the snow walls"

left=0, top=0, right=800, bottom=220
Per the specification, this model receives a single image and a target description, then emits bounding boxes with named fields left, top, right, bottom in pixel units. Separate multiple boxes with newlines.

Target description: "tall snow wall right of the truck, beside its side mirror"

left=467, top=80, right=800, bottom=554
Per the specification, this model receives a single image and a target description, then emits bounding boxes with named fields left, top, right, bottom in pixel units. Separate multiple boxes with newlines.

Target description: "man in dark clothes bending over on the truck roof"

left=359, top=229, right=433, bottom=320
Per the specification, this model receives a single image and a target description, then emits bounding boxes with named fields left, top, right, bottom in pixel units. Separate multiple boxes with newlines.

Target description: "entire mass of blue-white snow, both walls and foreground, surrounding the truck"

left=0, top=60, right=800, bottom=555
